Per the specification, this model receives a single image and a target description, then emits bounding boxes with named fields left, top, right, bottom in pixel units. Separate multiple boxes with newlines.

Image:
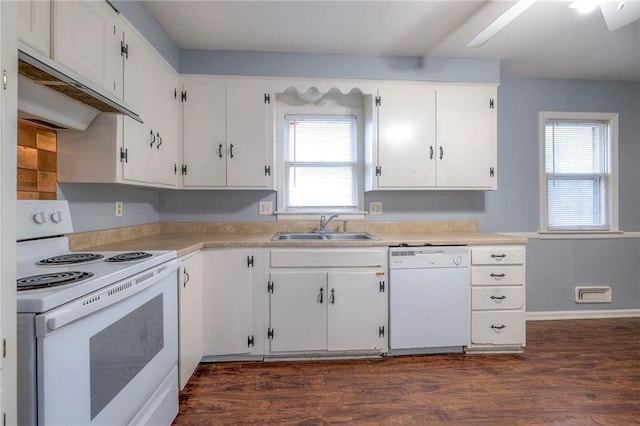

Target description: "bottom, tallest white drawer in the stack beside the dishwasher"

left=471, top=311, right=525, bottom=345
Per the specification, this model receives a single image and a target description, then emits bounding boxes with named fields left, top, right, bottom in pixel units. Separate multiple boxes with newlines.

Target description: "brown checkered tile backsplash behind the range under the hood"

left=17, top=121, right=57, bottom=200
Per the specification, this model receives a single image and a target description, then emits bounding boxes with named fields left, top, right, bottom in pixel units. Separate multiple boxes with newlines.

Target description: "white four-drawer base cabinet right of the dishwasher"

left=467, top=245, right=526, bottom=353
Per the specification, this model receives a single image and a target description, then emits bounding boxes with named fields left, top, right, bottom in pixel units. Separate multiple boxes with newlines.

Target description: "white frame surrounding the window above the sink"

left=276, top=100, right=366, bottom=220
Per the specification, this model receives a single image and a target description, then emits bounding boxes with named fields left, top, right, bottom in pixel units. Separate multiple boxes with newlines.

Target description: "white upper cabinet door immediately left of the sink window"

left=227, top=84, right=271, bottom=188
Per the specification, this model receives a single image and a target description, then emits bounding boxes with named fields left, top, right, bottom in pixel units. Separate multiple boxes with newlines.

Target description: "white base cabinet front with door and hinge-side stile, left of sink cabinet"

left=203, top=248, right=266, bottom=358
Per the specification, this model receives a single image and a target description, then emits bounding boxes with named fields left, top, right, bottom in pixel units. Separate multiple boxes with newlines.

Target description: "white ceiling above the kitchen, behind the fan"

left=144, top=0, right=640, bottom=81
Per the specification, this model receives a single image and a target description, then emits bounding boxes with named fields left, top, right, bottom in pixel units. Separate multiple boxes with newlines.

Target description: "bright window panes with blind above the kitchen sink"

left=283, top=115, right=359, bottom=213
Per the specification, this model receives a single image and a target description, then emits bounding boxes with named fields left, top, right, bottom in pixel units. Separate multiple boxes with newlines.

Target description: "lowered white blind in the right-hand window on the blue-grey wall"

left=545, top=120, right=611, bottom=230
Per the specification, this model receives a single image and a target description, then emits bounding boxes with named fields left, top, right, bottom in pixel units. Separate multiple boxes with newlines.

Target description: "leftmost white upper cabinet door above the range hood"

left=18, top=0, right=51, bottom=57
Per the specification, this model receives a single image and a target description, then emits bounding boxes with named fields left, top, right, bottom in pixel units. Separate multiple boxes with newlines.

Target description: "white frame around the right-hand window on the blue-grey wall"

left=538, top=111, right=620, bottom=236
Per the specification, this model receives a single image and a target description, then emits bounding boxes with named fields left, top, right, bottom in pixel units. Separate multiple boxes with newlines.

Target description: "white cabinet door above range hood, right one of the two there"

left=53, top=0, right=122, bottom=99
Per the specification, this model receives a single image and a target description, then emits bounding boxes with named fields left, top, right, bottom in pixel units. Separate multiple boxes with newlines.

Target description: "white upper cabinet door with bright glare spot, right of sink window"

left=378, top=85, right=436, bottom=189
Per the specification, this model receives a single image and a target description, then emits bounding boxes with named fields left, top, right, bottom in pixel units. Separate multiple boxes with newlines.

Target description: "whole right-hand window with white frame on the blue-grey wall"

left=540, top=112, right=618, bottom=232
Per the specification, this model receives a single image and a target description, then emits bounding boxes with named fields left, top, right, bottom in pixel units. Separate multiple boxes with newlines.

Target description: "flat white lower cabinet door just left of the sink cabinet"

left=203, top=249, right=253, bottom=356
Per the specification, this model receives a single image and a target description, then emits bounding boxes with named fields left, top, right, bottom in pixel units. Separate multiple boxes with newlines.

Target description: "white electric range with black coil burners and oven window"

left=16, top=201, right=178, bottom=425
